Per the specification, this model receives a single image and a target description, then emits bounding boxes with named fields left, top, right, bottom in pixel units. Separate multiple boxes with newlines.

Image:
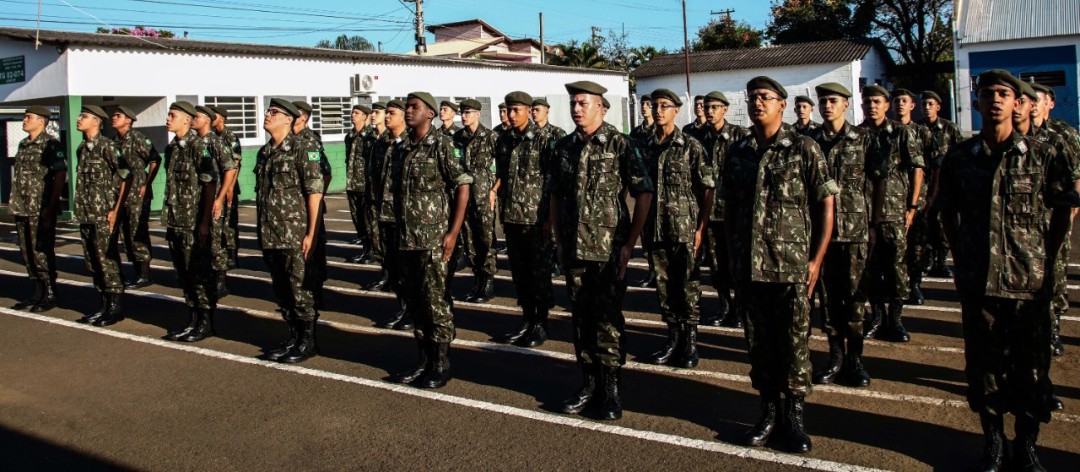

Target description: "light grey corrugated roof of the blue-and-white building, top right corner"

left=956, top=0, right=1080, bottom=44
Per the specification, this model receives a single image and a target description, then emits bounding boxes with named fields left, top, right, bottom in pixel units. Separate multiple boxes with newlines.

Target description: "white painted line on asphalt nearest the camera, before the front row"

left=0, top=308, right=878, bottom=472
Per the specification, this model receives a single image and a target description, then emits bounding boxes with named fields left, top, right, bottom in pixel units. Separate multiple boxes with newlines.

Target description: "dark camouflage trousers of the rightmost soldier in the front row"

left=960, top=294, right=1054, bottom=422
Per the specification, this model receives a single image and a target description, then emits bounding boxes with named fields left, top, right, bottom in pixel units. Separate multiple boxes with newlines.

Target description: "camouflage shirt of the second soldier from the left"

left=75, top=134, right=131, bottom=225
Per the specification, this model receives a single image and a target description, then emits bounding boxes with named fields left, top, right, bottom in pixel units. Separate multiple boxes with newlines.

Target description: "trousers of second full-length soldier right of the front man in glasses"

left=864, top=221, right=910, bottom=304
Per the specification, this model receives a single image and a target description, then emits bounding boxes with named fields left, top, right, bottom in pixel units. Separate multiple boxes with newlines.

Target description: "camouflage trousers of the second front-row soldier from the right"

left=735, top=282, right=811, bottom=396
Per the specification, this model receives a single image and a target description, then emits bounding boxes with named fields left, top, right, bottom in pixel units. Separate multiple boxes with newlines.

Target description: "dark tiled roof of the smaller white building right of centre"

left=630, top=40, right=891, bottom=78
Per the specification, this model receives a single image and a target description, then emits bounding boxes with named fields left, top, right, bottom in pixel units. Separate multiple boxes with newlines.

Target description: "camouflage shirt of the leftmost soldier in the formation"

left=9, top=132, right=67, bottom=216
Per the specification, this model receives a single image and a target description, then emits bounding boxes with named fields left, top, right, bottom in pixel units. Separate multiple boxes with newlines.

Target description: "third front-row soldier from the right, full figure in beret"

left=545, top=81, right=653, bottom=419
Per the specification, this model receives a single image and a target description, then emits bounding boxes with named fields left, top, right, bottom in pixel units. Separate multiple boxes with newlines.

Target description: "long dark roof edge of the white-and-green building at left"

left=0, top=27, right=623, bottom=76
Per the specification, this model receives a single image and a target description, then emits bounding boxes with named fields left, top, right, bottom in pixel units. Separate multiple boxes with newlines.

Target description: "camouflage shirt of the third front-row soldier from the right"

left=545, top=123, right=653, bottom=262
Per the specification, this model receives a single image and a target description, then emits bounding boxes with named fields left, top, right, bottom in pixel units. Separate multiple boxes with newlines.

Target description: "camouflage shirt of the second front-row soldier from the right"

left=719, top=124, right=840, bottom=283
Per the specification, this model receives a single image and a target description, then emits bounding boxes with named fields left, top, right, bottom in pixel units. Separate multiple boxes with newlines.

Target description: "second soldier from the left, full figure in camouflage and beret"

left=75, top=105, right=132, bottom=326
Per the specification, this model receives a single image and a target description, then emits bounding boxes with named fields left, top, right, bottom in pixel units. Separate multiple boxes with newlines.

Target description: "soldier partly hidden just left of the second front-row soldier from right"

left=701, top=91, right=750, bottom=328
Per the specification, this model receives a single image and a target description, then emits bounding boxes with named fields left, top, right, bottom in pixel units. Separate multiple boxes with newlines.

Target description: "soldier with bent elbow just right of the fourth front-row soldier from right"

left=454, top=98, right=498, bottom=304
